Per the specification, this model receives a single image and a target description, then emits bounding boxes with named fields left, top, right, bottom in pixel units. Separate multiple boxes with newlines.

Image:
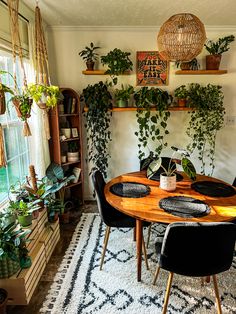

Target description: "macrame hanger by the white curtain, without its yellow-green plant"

left=35, top=1, right=51, bottom=140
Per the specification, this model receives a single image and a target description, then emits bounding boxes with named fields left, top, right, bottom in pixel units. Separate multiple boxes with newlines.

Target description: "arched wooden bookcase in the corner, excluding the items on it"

left=49, top=88, right=84, bottom=203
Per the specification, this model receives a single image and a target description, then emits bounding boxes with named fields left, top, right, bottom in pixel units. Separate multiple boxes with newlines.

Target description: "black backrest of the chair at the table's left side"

left=92, top=170, right=114, bottom=225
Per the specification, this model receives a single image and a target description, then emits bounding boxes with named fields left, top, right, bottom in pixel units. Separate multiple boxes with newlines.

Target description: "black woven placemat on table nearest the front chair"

left=159, top=196, right=211, bottom=218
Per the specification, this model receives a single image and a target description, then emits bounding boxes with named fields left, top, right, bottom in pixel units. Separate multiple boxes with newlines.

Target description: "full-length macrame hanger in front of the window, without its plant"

left=7, top=0, right=31, bottom=136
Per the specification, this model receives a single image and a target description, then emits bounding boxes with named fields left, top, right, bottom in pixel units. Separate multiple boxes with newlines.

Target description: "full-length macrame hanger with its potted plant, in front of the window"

left=7, top=0, right=32, bottom=136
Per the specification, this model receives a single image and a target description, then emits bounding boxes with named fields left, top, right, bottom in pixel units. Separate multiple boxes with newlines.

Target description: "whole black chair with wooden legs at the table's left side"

left=92, top=170, right=150, bottom=270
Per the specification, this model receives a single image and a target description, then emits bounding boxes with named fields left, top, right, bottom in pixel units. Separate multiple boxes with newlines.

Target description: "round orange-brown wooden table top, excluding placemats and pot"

left=105, top=171, right=236, bottom=223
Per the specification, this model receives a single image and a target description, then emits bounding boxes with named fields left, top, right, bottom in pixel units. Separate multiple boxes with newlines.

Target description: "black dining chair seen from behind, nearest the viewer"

left=153, top=222, right=236, bottom=314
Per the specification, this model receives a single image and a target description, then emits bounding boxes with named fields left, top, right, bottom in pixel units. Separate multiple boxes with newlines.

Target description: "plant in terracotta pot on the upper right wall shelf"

left=204, top=35, right=235, bottom=70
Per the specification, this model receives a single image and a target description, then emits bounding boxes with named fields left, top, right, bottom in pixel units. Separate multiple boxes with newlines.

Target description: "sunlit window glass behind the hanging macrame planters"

left=0, top=50, right=29, bottom=203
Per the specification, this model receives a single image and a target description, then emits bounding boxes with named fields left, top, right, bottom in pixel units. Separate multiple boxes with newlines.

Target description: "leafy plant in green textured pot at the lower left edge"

left=0, top=218, right=31, bottom=278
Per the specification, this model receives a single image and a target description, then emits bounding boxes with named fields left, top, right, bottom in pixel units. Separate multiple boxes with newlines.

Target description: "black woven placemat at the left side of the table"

left=110, top=182, right=151, bottom=198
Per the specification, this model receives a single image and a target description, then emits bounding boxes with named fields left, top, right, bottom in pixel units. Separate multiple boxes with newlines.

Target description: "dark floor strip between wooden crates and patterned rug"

left=7, top=202, right=97, bottom=314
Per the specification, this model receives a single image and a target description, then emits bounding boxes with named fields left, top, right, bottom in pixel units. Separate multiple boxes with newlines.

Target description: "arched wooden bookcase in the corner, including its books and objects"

left=49, top=88, right=84, bottom=204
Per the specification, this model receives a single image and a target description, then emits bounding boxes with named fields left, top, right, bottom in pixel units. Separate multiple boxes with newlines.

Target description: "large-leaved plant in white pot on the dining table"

left=147, top=146, right=196, bottom=191
